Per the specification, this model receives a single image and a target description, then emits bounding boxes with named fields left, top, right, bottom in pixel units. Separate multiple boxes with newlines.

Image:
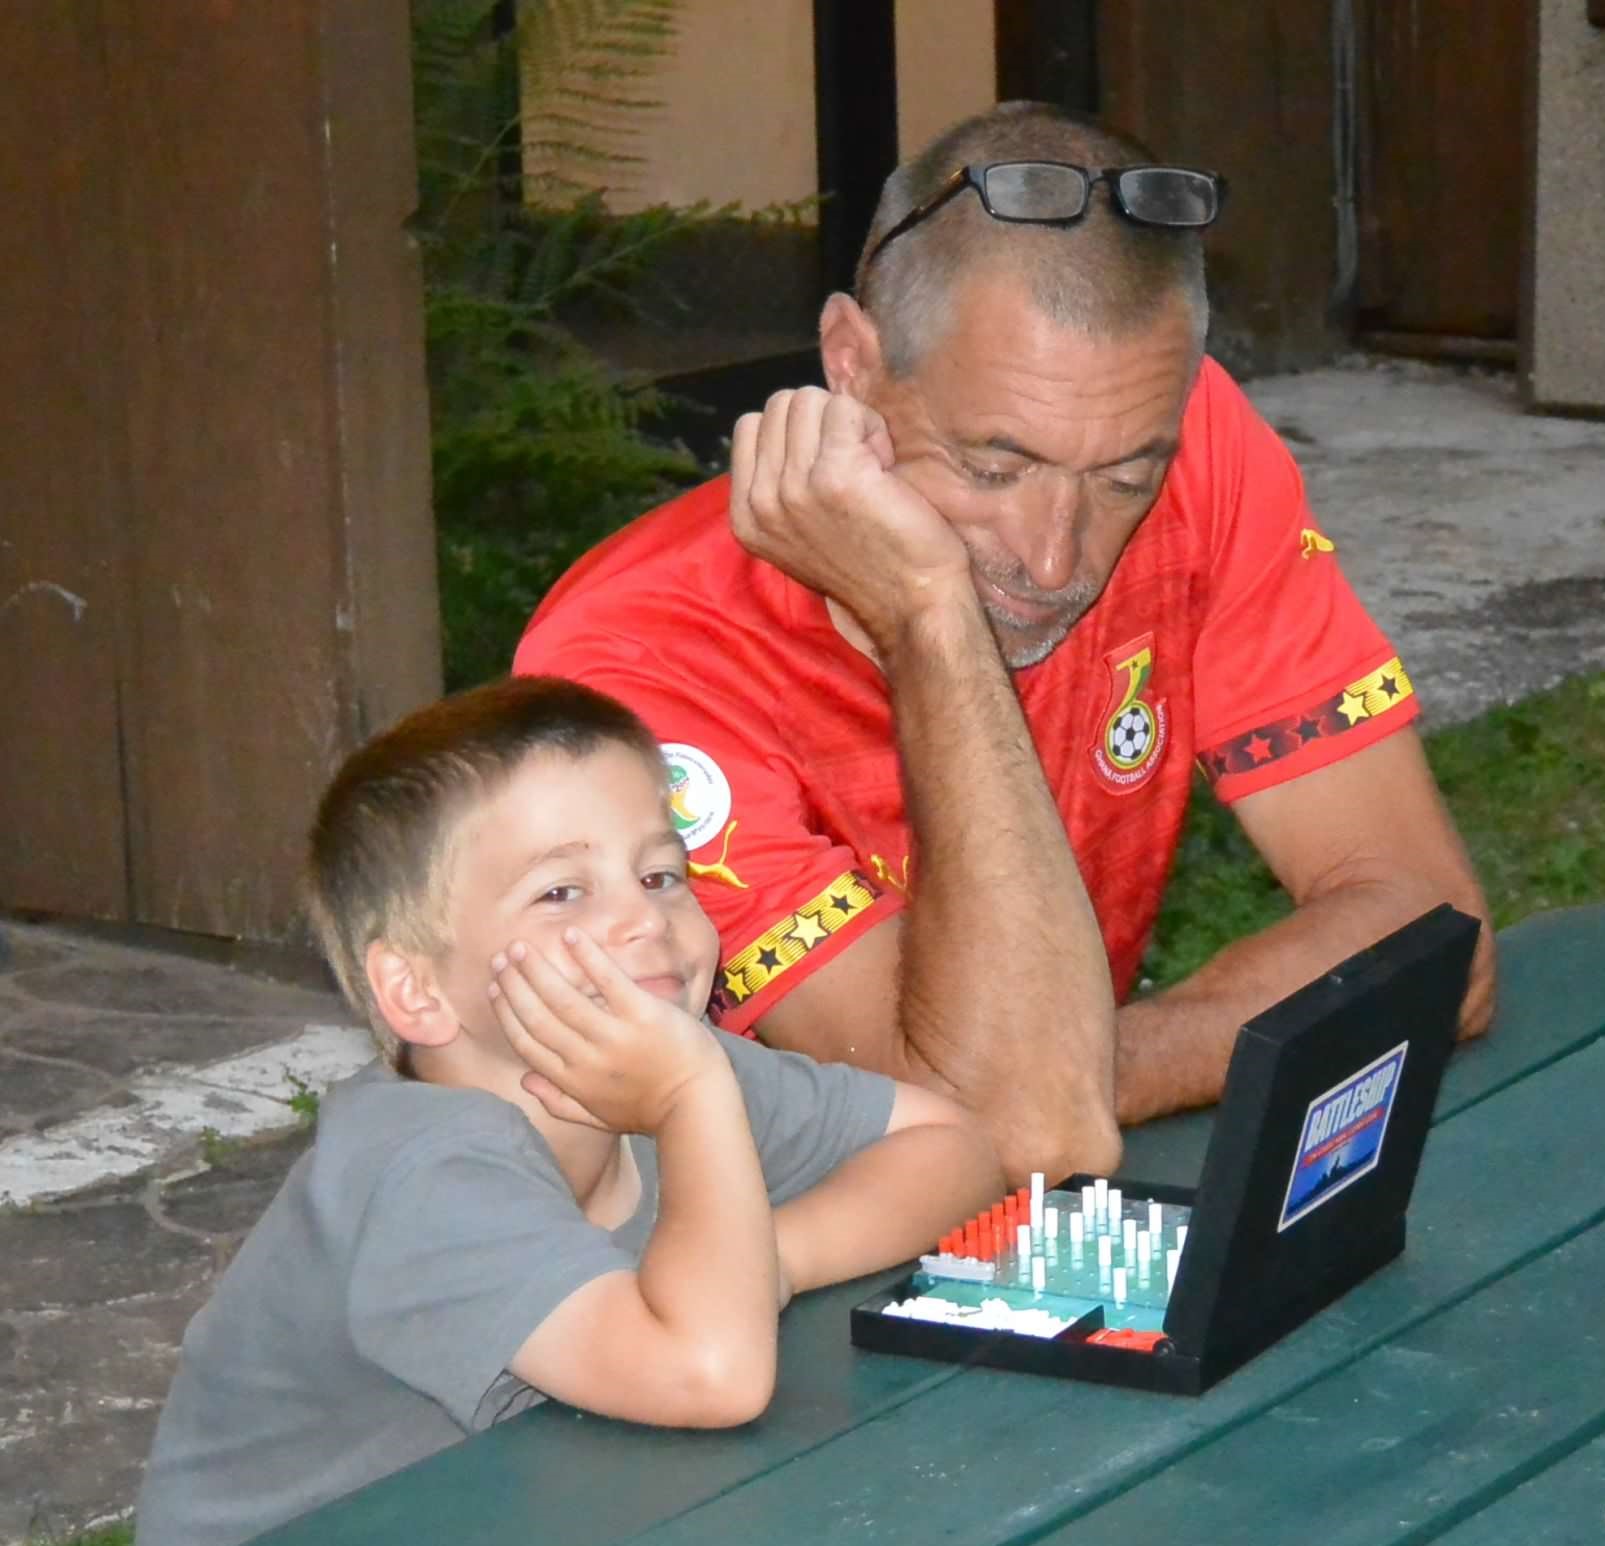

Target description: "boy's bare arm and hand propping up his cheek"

left=496, top=936, right=780, bottom=1427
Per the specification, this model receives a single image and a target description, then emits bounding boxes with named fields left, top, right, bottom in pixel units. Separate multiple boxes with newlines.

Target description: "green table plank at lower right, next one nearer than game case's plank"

left=1042, top=1228, right=1605, bottom=1546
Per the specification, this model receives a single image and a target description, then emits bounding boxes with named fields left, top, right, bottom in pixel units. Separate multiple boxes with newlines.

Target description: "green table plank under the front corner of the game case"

left=609, top=1044, right=1605, bottom=1546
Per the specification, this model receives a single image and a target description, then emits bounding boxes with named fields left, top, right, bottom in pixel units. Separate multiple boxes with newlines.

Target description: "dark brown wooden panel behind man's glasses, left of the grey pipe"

left=1098, top=0, right=1340, bottom=371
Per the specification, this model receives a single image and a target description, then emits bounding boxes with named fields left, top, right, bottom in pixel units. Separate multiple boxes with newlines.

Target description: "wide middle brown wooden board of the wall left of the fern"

left=106, top=0, right=340, bottom=934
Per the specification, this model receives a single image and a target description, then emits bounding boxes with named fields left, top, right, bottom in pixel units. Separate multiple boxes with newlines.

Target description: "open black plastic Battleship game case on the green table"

left=852, top=905, right=1480, bottom=1395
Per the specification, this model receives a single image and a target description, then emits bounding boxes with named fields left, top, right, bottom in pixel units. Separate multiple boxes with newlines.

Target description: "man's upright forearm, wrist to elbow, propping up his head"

left=881, top=604, right=1120, bottom=1180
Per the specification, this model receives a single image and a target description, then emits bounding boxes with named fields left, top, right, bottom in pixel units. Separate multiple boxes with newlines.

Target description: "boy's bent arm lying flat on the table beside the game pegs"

left=775, top=1084, right=1005, bottom=1292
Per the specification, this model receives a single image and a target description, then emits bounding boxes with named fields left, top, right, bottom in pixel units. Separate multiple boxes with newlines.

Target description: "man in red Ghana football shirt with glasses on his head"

left=515, top=103, right=1493, bottom=1178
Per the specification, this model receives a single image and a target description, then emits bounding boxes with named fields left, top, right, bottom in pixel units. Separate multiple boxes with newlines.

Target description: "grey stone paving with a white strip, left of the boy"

left=0, top=920, right=357, bottom=1546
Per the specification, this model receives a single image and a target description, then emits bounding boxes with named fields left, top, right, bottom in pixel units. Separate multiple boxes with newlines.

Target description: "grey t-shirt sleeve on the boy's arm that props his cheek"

left=347, top=1106, right=636, bottom=1432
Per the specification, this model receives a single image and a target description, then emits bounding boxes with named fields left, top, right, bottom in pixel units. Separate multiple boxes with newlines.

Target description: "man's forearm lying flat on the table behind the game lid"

left=1115, top=880, right=1493, bottom=1124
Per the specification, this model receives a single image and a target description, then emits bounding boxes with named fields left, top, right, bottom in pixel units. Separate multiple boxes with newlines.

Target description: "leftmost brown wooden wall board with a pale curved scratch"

left=0, top=0, right=128, bottom=917
